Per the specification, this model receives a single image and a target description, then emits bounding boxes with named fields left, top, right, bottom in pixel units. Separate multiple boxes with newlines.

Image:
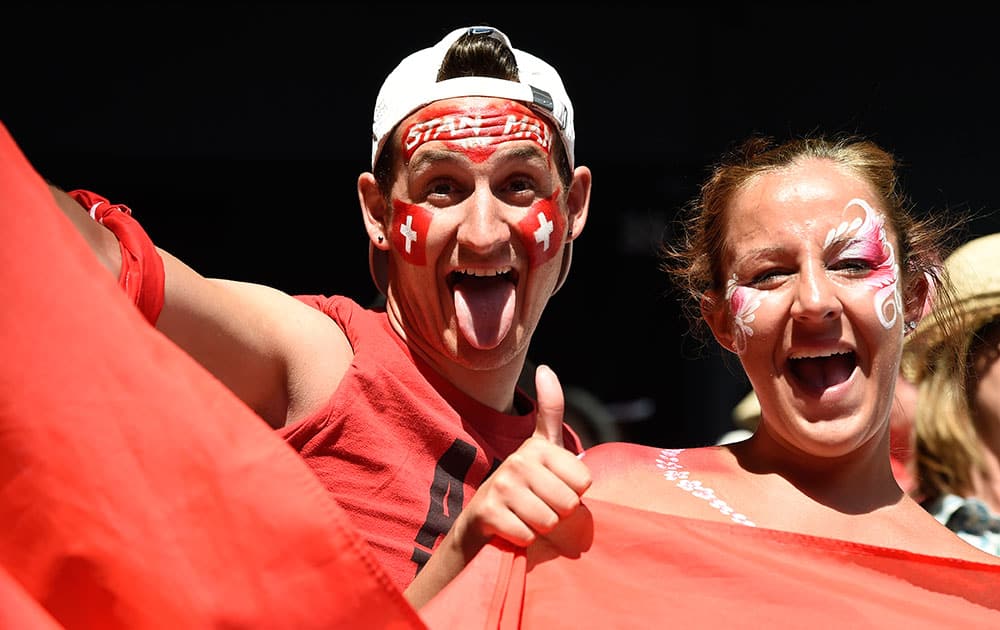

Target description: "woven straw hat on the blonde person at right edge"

left=903, top=232, right=1000, bottom=377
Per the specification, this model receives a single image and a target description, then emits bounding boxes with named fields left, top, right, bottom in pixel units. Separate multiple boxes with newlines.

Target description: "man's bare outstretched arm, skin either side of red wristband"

left=50, top=186, right=353, bottom=428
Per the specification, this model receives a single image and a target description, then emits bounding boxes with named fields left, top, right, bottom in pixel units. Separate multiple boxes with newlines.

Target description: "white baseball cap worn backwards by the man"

left=368, top=26, right=576, bottom=294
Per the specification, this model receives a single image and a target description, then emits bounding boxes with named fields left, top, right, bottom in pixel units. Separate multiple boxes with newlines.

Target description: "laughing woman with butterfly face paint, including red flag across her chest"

left=422, top=137, right=1000, bottom=628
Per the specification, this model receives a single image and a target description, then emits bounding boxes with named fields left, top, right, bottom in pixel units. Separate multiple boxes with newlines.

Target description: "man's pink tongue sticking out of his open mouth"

left=455, top=276, right=515, bottom=350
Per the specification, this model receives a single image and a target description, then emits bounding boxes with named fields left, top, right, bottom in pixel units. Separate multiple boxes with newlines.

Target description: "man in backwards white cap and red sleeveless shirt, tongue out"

left=54, top=26, right=591, bottom=603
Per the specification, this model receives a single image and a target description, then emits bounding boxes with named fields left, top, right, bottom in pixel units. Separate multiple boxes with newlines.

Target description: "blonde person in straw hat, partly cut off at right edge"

left=903, top=233, right=1000, bottom=555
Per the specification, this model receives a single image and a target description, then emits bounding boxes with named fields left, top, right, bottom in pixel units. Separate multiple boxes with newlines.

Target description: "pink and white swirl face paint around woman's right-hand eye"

left=823, top=199, right=903, bottom=330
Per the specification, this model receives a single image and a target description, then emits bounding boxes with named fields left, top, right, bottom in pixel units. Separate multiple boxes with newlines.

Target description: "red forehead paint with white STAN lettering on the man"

left=403, top=101, right=552, bottom=162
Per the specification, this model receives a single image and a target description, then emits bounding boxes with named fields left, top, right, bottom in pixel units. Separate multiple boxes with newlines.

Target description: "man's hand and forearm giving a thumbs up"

left=406, top=365, right=591, bottom=608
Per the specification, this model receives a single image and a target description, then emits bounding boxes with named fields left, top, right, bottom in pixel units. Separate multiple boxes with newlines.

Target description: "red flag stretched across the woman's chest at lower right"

left=421, top=499, right=1000, bottom=630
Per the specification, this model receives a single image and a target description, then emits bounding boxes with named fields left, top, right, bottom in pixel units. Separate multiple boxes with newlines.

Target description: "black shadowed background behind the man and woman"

left=7, top=2, right=1000, bottom=446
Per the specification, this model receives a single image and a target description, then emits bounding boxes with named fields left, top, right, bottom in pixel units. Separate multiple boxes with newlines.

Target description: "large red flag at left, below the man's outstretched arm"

left=0, top=124, right=424, bottom=630
